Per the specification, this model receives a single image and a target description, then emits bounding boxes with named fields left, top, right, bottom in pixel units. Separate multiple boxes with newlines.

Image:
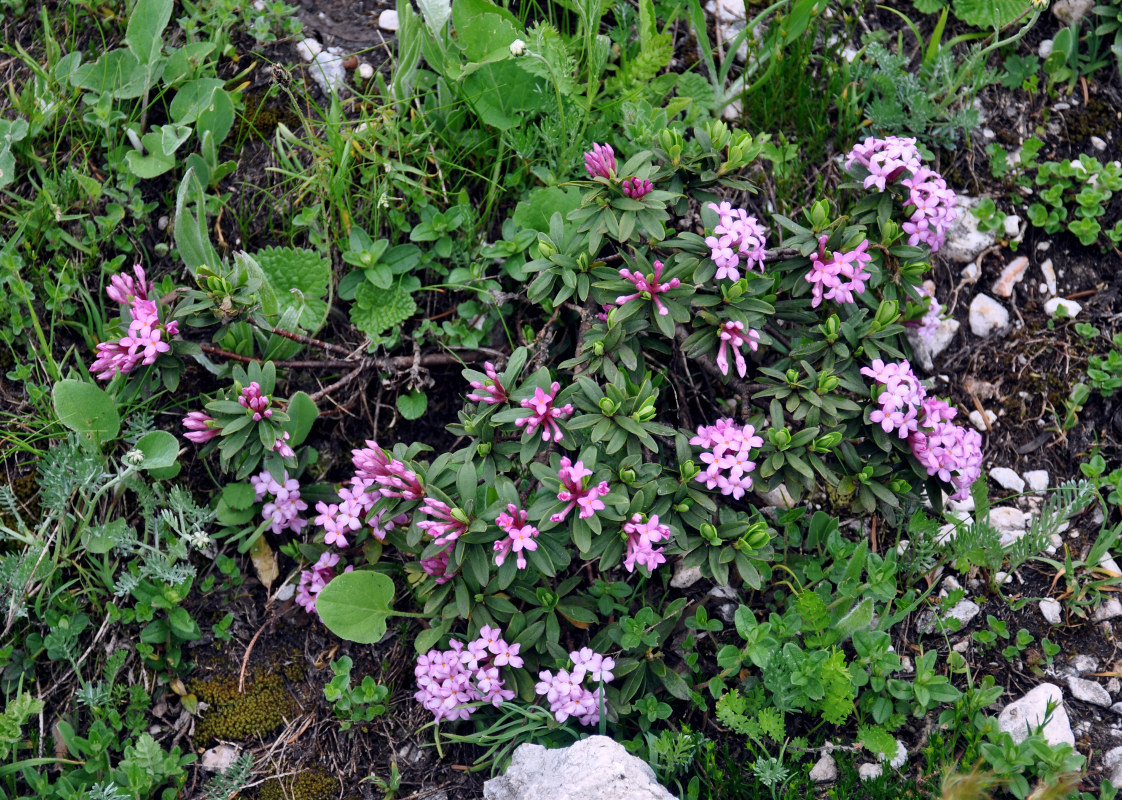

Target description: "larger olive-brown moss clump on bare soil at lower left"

left=191, top=670, right=296, bottom=745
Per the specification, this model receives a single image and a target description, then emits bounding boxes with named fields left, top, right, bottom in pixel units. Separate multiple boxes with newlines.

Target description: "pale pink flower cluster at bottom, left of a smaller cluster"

left=413, top=625, right=523, bottom=723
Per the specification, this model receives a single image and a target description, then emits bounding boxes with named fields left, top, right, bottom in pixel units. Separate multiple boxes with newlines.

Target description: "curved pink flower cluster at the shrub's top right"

left=845, top=136, right=958, bottom=252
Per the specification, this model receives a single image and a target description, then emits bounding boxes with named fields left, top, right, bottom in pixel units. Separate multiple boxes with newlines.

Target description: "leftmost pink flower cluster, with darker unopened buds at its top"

left=90, top=264, right=180, bottom=380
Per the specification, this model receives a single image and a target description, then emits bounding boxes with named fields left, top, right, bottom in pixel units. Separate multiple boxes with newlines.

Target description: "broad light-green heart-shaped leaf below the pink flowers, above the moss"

left=315, top=570, right=394, bottom=644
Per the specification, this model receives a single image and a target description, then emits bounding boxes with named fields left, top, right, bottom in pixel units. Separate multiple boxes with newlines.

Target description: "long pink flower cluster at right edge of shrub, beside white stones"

left=861, top=359, right=982, bottom=500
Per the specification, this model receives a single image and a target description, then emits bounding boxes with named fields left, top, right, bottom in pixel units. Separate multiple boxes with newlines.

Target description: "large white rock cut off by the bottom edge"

left=484, top=736, right=674, bottom=800
